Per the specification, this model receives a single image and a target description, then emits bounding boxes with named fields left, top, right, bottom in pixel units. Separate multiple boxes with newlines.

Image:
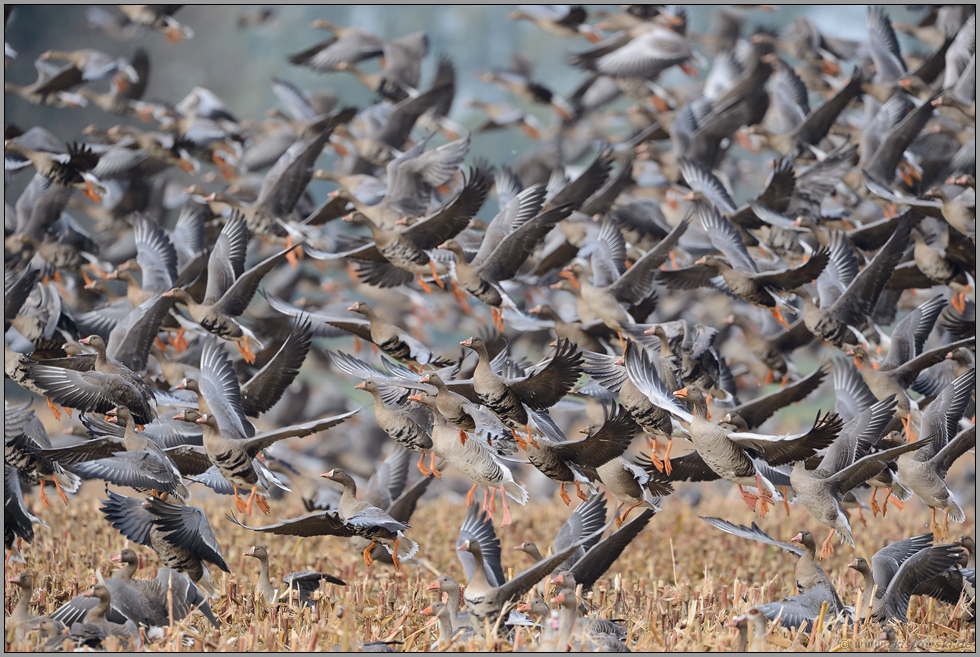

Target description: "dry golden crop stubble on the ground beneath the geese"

left=5, top=476, right=976, bottom=652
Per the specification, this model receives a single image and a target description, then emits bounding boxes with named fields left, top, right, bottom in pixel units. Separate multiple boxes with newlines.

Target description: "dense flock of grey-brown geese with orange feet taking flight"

left=4, top=5, right=976, bottom=651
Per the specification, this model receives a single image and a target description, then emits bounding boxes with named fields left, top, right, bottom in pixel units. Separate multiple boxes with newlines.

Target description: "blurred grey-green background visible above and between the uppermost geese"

left=4, top=5, right=921, bottom=172
